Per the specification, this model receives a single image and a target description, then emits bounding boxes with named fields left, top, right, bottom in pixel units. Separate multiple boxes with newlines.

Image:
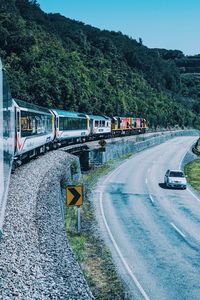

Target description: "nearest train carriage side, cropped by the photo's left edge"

left=0, top=60, right=15, bottom=232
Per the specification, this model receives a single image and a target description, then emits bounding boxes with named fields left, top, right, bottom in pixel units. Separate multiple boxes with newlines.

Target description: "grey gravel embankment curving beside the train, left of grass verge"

left=0, top=151, right=93, bottom=300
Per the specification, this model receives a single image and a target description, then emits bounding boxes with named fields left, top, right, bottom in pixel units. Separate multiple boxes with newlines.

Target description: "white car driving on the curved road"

left=164, top=170, right=187, bottom=189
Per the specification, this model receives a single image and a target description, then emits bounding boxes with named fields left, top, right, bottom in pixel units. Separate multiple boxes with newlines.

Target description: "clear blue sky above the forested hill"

left=38, top=0, right=200, bottom=55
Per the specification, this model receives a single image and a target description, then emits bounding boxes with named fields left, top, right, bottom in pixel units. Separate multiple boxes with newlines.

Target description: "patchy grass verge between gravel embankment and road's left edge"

left=66, top=154, right=132, bottom=300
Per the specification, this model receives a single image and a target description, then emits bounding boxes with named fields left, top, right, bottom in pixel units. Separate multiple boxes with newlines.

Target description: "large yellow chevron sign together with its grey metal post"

left=66, top=185, right=83, bottom=233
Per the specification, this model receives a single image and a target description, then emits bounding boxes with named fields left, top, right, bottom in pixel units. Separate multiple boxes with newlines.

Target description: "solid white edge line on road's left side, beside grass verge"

left=97, top=166, right=150, bottom=300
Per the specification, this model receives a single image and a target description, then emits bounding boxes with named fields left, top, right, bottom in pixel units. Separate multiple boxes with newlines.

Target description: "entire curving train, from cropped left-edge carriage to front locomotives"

left=0, top=60, right=147, bottom=227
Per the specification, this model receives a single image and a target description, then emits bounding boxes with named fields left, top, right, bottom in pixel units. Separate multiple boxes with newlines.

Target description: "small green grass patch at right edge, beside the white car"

left=185, top=159, right=200, bottom=191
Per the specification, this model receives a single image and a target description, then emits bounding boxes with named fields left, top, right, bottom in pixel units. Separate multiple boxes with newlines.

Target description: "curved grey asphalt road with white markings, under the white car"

left=99, top=137, right=200, bottom=300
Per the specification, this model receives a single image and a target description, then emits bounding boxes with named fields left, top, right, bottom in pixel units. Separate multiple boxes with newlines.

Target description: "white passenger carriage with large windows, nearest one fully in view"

left=14, top=99, right=55, bottom=164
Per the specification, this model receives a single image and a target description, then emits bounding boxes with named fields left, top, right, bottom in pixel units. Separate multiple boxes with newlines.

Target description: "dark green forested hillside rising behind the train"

left=0, top=0, right=200, bottom=127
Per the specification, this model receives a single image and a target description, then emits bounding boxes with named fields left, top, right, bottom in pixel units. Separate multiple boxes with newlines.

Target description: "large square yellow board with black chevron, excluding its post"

left=66, top=185, right=83, bottom=206
